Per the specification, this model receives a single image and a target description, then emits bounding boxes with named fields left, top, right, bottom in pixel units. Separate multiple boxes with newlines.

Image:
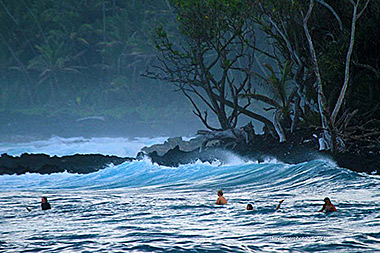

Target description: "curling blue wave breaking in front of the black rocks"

left=0, top=157, right=374, bottom=190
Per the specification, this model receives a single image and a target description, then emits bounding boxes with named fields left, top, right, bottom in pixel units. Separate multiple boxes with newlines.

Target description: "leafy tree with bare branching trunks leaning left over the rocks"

left=145, top=3, right=275, bottom=131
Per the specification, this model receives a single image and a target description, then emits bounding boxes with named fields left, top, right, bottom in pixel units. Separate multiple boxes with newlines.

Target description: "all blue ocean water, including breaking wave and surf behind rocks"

left=0, top=137, right=380, bottom=252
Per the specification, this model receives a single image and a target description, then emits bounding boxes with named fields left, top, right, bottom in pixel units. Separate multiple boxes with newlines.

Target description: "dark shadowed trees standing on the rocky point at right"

left=146, top=0, right=380, bottom=152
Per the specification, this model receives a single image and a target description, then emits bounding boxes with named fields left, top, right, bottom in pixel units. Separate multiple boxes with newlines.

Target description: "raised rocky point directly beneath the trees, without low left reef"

left=142, top=128, right=380, bottom=175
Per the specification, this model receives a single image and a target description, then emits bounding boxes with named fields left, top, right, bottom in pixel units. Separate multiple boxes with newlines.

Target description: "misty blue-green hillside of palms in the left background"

left=0, top=0, right=199, bottom=136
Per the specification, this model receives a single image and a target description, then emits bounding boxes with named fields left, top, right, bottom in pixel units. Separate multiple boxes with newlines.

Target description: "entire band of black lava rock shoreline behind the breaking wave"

left=0, top=125, right=380, bottom=175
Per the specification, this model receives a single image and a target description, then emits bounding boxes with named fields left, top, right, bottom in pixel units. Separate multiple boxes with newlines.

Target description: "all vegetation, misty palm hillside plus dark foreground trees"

left=0, top=0, right=380, bottom=148
